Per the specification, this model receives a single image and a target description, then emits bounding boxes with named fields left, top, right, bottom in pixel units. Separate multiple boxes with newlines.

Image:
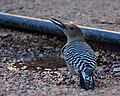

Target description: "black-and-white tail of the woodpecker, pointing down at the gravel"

left=80, top=72, right=95, bottom=91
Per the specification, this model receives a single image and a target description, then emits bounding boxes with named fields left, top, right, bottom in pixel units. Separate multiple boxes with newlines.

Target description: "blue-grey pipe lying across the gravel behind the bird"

left=0, top=12, right=120, bottom=45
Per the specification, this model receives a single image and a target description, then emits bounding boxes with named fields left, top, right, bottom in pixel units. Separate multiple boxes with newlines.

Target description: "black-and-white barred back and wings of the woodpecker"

left=63, top=40, right=96, bottom=74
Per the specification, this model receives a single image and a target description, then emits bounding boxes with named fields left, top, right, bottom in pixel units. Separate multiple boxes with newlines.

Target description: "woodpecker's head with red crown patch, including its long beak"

left=51, top=18, right=84, bottom=40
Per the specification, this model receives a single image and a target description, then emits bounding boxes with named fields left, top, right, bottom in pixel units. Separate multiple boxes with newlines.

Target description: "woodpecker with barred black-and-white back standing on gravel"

left=50, top=18, right=96, bottom=91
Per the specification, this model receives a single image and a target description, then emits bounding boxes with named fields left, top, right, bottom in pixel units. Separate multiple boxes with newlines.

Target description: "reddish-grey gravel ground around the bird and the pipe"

left=0, top=0, right=120, bottom=96
